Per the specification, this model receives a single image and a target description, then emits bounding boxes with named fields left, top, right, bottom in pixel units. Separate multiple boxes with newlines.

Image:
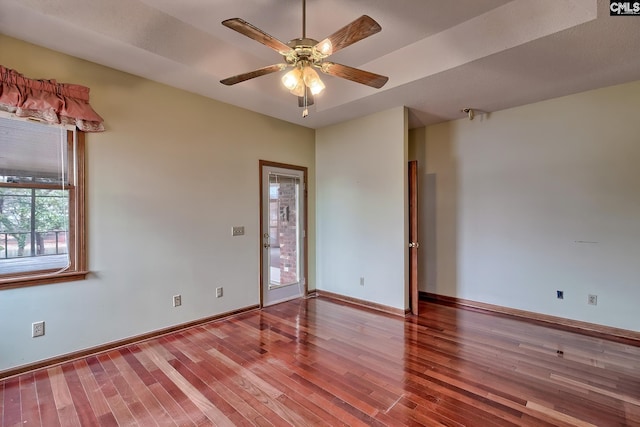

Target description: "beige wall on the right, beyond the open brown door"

left=410, top=82, right=640, bottom=331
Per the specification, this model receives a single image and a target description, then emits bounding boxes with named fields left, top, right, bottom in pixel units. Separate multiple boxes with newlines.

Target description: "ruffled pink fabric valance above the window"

left=0, top=65, right=104, bottom=132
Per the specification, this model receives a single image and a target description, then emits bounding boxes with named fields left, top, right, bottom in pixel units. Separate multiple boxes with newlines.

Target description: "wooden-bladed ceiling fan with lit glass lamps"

left=220, top=0, right=389, bottom=117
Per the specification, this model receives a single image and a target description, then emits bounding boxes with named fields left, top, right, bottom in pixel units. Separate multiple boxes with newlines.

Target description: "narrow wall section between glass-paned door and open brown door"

left=316, top=107, right=408, bottom=309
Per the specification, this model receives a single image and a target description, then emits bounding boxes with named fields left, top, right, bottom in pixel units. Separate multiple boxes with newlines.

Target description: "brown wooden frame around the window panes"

left=0, top=124, right=89, bottom=291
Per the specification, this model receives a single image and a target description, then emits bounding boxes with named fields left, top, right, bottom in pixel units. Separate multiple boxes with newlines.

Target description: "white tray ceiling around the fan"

left=0, top=0, right=640, bottom=128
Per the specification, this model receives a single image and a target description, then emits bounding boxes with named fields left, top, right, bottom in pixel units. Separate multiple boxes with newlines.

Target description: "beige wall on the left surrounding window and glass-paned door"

left=0, top=36, right=315, bottom=371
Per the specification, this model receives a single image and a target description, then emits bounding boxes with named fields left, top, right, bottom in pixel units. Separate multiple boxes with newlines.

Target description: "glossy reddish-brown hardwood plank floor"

left=0, top=299, right=640, bottom=427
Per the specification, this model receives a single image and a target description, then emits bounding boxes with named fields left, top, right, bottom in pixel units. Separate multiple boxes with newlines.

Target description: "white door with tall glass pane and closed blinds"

left=262, top=166, right=304, bottom=306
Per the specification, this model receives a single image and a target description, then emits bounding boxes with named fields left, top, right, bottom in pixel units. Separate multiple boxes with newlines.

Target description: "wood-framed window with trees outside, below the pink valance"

left=0, top=116, right=86, bottom=289
